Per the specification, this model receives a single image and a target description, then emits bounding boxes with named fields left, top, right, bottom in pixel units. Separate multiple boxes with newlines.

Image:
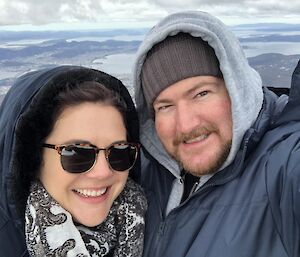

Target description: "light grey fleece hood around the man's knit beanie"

left=133, top=11, right=263, bottom=178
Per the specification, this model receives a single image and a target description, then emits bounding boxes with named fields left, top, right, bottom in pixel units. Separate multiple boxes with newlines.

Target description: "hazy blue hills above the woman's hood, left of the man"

left=0, top=39, right=140, bottom=80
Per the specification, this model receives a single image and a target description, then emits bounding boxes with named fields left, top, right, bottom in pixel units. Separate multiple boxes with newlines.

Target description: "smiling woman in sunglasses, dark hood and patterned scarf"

left=0, top=66, right=146, bottom=257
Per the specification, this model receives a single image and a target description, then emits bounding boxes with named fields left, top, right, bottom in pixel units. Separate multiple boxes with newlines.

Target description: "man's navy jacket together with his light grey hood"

left=133, top=12, right=300, bottom=257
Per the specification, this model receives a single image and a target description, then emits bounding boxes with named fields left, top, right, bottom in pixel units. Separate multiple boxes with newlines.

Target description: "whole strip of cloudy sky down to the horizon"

left=0, top=0, right=300, bottom=30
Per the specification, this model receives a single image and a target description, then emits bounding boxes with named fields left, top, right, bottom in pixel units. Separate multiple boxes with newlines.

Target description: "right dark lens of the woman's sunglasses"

left=108, top=144, right=137, bottom=171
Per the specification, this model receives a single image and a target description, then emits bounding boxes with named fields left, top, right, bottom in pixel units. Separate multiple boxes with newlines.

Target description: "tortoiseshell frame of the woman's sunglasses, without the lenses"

left=42, top=141, right=141, bottom=174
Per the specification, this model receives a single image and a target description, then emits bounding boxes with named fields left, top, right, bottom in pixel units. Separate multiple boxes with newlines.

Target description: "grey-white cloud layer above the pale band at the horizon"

left=0, top=0, right=300, bottom=26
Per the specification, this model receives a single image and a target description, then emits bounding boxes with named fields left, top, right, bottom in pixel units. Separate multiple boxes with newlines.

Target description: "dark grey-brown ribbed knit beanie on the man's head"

left=141, top=33, right=222, bottom=112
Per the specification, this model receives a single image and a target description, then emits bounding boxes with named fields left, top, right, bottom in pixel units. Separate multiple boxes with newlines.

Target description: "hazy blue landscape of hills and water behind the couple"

left=0, top=26, right=300, bottom=97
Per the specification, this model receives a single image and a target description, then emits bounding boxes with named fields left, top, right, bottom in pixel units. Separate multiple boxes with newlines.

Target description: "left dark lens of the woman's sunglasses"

left=61, top=145, right=96, bottom=173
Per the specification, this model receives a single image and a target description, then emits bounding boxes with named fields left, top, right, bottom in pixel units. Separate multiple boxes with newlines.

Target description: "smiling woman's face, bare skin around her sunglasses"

left=40, top=103, right=128, bottom=227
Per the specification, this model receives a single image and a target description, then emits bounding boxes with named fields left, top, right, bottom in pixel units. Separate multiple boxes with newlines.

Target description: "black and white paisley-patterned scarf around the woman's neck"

left=25, top=178, right=147, bottom=257
